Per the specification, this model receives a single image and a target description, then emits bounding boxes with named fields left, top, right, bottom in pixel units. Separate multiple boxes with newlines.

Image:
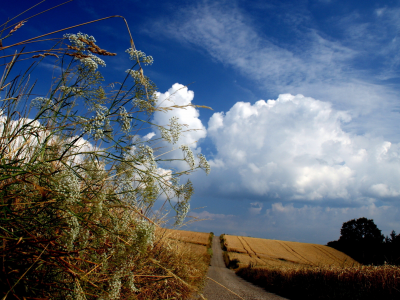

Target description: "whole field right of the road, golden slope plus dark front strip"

left=221, top=235, right=400, bottom=299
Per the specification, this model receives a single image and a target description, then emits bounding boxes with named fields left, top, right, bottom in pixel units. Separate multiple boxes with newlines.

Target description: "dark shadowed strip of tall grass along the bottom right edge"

left=236, top=265, right=400, bottom=300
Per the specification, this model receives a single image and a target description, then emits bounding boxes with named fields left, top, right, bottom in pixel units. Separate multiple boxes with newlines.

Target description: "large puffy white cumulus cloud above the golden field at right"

left=208, top=94, right=400, bottom=203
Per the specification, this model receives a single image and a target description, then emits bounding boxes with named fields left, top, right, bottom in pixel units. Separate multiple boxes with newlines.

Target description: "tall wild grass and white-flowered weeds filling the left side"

left=0, top=3, right=209, bottom=299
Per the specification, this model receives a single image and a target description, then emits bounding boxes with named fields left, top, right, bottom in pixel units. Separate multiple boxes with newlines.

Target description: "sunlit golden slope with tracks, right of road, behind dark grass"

left=223, top=235, right=359, bottom=267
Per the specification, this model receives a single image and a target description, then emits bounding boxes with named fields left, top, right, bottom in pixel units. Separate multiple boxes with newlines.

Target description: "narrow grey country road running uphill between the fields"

left=196, top=236, right=285, bottom=300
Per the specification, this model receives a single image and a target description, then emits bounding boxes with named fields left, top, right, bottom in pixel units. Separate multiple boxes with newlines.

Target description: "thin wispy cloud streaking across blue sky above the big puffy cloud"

left=157, top=1, right=400, bottom=141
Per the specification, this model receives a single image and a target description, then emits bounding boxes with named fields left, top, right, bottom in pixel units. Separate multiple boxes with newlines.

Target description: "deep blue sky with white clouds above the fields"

left=0, top=0, right=400, bottom=244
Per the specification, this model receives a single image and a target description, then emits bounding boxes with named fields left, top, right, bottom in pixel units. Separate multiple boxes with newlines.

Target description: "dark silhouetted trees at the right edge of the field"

left=327, top=217, right=400, bottom=265
